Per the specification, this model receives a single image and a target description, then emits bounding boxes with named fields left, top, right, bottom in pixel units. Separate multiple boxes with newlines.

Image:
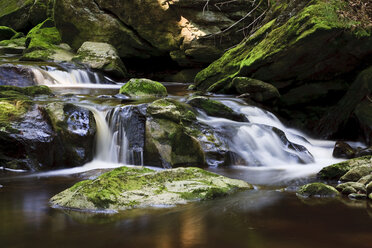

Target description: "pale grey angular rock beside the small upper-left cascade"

left=73, top=41, right=128, bottom=78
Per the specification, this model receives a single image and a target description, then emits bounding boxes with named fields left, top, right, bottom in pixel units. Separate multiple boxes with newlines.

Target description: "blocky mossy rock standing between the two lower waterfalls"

left=144, top=99, right=206, bottom=168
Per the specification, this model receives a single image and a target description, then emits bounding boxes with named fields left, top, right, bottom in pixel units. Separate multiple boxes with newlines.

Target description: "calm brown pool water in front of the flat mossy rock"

left=0, top=171, right=372, bottom=248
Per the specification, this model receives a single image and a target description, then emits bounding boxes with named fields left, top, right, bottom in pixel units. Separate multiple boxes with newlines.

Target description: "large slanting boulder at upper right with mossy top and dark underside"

left=195, top=0, right=372, bottom=92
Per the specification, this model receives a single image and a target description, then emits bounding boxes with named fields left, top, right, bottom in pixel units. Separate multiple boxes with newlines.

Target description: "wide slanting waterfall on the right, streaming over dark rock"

left=199, top=99, right=338, bottom=168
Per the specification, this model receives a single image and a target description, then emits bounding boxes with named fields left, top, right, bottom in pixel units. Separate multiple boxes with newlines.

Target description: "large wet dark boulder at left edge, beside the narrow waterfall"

left=0, top=86, right=96, bottom=170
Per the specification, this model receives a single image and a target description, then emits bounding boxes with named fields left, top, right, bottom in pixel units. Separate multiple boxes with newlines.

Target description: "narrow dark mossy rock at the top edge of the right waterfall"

left=187, top=96, right=248, bottom=122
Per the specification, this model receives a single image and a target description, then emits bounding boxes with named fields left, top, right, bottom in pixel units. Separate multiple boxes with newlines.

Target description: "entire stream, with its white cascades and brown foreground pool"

left=0, top=67, right=372, bottom=248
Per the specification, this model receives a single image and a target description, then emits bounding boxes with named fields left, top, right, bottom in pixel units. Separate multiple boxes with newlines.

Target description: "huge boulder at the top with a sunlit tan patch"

left=54, top=0, right=267, bottom=66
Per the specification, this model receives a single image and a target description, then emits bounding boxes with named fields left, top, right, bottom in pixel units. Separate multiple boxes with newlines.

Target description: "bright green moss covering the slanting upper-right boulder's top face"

left=195, top=0, right=371, bottom=93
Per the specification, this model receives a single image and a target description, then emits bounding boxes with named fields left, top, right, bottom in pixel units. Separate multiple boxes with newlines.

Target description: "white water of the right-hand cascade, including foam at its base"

left=198, top=100, right=342, bottom=182
